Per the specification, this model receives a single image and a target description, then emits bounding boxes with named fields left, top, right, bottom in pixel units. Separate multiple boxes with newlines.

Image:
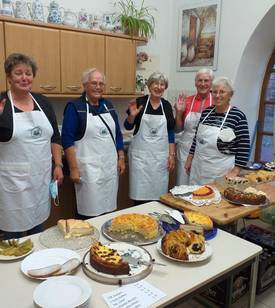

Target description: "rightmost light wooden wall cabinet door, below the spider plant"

left=105, top=37, right=136, bottom=94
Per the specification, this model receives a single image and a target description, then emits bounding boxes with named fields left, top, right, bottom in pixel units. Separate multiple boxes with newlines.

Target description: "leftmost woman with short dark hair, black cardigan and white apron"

left=0, top=54, right=63, bottom=238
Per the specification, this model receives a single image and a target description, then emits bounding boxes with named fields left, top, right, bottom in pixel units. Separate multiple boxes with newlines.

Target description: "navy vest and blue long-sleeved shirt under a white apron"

left=61, top=93, right=124, bottom=151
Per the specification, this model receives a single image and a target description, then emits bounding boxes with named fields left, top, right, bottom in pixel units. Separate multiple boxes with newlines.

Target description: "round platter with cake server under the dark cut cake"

left=82, top=242, right=153, bottom=285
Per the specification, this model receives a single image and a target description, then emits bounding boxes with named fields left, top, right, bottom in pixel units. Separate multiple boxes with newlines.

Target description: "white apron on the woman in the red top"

left=176, top=94, right=212, bottom=185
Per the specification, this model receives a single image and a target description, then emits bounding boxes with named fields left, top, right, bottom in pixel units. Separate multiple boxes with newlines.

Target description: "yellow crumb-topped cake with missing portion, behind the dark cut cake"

left=110, top=214, right=158, bottom=239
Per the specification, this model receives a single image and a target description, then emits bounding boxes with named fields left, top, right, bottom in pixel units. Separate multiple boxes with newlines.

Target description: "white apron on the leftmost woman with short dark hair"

left=0, top=91, right=53, bottom=232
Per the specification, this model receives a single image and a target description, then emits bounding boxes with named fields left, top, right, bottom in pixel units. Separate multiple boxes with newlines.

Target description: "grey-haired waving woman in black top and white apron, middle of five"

left=124, top=73, right=175, bottom=204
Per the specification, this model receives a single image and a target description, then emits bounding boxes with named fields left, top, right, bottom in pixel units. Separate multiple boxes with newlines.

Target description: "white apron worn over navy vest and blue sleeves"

left=75, top=103, right=118, bottom=216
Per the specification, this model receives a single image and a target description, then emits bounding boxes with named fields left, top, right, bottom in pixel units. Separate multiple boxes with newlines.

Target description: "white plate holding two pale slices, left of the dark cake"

left=21, top=248, right=81, bottom=280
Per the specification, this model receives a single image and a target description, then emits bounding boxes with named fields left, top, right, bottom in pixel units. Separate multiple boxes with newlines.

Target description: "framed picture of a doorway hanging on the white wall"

left=177, top=0, right=221, bottom=71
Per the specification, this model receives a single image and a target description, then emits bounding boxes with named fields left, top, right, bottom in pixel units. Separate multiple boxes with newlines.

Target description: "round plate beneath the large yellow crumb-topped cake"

left=101, top=219, right=165, bottom=246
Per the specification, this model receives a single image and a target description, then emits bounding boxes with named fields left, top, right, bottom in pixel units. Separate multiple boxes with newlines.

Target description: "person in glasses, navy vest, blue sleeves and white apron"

left=62, top=69, right=125, bottom=218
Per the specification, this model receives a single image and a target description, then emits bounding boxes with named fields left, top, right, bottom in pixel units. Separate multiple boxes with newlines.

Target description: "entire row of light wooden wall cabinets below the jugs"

left=0, top=16, right=146, bottom=97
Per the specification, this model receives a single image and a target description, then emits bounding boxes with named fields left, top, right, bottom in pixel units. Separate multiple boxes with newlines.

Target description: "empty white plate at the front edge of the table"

left=33, top=276, right=92, bottom=308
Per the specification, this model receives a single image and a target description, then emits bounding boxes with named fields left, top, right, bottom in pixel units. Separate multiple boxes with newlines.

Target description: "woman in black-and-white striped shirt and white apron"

left=185, top=77, right=250, bottom=185
